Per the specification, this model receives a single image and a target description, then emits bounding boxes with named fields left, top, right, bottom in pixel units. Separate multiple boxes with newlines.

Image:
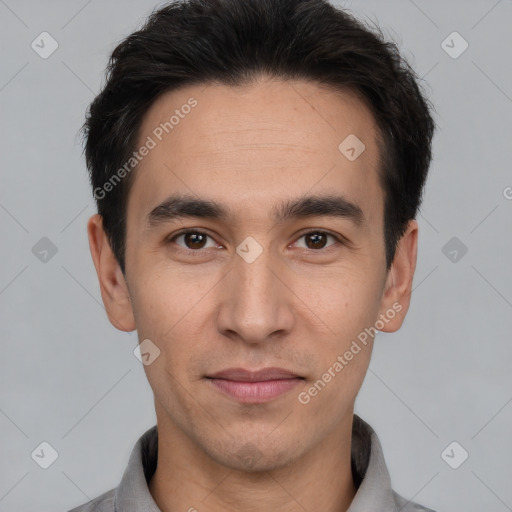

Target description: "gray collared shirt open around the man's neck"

left=69, top=414, right=434, bottom=512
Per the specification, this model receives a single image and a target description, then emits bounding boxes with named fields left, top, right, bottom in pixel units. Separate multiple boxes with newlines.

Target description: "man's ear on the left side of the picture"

left=87, top=214, right=135, bottom=332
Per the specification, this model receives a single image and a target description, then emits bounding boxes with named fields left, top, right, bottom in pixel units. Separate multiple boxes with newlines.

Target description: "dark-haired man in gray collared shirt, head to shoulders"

left=74, top=0, right=434, bottom=512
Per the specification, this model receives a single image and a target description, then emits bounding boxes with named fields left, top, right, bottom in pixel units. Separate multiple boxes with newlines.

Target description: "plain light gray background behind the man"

left=0, top=0, right=512, bottom=512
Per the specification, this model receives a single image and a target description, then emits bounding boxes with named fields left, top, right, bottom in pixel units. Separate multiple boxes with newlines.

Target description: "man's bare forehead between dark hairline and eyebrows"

left=128, top=80, right=383, bottom=230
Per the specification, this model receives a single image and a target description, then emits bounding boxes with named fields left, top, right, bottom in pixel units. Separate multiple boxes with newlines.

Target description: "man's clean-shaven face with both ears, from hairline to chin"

left=89, top=80, right=416, bottom=470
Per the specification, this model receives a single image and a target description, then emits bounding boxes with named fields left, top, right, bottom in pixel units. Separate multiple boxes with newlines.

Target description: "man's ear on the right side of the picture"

left=378, top=219, right=418, bottom=332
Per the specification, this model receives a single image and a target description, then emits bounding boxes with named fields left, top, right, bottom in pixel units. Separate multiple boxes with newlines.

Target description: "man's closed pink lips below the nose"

left=206, top=367, right=305, bottom=404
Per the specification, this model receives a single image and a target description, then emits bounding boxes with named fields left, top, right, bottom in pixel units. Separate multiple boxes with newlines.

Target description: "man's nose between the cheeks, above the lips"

left=217, top=244, right=294, bottom=344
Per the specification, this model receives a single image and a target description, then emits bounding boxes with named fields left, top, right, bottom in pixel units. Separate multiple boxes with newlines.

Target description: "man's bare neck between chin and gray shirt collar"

left=149, top=411, right=356, bottom=512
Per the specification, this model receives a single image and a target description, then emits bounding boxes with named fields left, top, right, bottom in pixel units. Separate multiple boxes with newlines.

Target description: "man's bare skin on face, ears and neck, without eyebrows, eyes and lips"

left=88, top=78, right=418, bottom=512
